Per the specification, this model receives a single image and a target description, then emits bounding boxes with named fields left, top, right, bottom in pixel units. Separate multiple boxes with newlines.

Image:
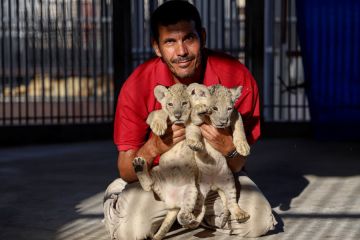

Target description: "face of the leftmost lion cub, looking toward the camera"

left=154, top=83, right=191, bottom=124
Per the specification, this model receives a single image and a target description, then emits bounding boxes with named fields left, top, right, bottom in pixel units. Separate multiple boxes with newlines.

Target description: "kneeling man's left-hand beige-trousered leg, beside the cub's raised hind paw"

left=104, top=178, right=166, bottom=240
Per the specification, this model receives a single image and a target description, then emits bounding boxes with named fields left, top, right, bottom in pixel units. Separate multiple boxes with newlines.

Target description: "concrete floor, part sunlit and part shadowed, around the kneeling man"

left=0, top=139, right=360, bottom=240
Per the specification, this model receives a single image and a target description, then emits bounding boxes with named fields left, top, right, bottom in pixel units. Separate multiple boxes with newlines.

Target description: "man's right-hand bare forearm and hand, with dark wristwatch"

left=200, top=124, right=246, bottom=173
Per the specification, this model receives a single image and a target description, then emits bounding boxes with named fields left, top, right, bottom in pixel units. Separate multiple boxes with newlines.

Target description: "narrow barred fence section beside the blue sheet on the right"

left=262, top=0, right=310, bottom=122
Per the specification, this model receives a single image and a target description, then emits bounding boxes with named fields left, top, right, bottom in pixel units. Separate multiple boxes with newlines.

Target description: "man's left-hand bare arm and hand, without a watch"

left=117, top=124, right=185, bottom=182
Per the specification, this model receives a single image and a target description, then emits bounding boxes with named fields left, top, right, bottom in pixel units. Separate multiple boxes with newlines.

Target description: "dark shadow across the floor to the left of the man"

left=0, top=141, right=117, bottom=240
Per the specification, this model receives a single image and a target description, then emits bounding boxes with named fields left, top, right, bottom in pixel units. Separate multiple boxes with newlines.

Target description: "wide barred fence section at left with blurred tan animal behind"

left=0, top=0, right=114, bottom=126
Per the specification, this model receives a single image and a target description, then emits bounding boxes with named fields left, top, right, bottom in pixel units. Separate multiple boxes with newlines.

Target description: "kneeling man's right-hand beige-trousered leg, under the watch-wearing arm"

left=204, top=172, right=277, bottom=237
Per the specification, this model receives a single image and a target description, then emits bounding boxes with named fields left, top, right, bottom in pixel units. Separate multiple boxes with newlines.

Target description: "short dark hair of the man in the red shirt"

left=151, top=0, right=202, bottom=42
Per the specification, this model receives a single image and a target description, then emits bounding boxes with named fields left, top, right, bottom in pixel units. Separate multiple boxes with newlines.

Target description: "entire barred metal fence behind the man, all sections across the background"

left=0, top=0, right=310, bottom=131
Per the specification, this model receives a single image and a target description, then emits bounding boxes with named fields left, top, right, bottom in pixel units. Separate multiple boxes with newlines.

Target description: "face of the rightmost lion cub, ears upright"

left=209, top=85, right=242, bottom=128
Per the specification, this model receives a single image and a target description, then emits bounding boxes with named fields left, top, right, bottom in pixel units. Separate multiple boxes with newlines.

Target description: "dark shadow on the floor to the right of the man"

left=247, top=139, right=360, bottom=234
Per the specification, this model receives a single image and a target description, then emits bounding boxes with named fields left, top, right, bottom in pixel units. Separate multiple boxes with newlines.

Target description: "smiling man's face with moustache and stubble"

left=153, top=21, right=205, bottom=80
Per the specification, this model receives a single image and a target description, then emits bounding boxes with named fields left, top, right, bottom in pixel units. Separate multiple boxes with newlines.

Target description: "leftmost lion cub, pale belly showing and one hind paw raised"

left=133, top=84, right=204, bottom=239
